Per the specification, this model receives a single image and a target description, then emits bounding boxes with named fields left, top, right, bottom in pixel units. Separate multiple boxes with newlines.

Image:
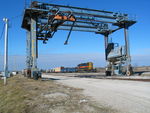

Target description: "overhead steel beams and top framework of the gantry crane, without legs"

left=22, top=1, right=135, bottom=40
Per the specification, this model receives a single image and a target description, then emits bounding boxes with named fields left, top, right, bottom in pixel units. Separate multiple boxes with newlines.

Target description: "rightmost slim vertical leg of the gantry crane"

left=124, top=25, right=131, bottom=76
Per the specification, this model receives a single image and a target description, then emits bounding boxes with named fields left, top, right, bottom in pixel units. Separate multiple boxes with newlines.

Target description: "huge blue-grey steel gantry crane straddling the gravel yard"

left=22, top=1, right=136, bottom=78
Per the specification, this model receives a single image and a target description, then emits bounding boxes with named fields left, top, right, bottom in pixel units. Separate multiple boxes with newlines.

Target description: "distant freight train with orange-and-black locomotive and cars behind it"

left=49, top=62, right=96, bottom=73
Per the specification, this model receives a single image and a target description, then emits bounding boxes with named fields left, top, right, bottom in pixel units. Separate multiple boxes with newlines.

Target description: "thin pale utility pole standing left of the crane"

left=3, top=18, right=8, bottom=85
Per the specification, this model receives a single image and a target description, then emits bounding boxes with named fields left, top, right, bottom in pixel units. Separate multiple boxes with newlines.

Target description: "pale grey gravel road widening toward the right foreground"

left=43, top=74, right=150, bottom=113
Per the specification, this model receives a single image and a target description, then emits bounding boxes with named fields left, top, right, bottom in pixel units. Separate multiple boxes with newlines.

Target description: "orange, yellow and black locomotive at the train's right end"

left=77, top=62, right=96, bottom=72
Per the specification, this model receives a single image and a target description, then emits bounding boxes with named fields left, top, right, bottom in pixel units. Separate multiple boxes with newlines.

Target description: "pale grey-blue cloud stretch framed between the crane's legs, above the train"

left=38, top=53, right=105, bottom=69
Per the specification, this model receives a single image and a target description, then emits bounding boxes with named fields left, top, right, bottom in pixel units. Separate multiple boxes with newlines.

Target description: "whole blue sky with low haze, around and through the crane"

left=0, top=0, right=150, bottom=70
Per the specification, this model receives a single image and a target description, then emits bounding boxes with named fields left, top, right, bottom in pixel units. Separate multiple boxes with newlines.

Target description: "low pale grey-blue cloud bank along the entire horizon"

left=0, top=53, right=150, bottom=70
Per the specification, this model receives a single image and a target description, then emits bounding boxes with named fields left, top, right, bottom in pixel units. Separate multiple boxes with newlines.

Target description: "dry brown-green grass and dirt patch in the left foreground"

left=0, top=75, right=117, bottom=113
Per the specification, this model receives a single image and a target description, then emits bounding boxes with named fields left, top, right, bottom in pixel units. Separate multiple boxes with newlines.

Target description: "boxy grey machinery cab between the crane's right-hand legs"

left=106, top=43, right=132, bottom=76
